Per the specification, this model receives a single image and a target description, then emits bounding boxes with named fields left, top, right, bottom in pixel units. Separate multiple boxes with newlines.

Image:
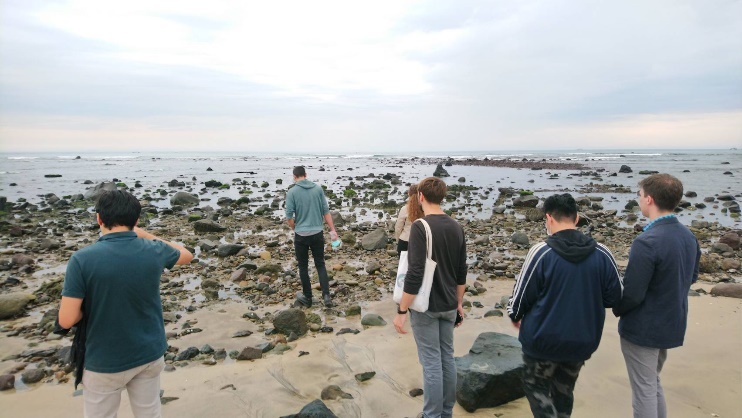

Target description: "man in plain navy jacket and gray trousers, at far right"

left=613, top=174, right=701, bottom=418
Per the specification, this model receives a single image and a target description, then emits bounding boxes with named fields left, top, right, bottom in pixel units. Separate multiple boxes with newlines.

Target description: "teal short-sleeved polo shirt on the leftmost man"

left=62, top=231, right=180, bottom=373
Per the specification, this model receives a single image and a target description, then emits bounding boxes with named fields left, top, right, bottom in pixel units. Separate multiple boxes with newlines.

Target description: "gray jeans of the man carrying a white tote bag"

left=410, top=309, right=456, bottom=418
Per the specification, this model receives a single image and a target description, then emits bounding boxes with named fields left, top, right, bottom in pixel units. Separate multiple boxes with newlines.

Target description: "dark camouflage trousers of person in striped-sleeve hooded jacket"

left=523, top=354, right=585, bottom=418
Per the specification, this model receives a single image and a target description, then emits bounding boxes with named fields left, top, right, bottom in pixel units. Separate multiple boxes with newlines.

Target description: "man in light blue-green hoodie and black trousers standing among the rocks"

left=286, top=166, right=338, bottom=308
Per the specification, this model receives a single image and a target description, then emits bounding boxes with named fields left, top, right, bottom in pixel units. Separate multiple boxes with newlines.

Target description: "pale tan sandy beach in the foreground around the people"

left=0, top=280, right=742, bottom=418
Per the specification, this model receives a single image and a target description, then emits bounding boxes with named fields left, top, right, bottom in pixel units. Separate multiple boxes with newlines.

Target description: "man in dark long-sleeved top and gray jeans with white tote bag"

left=394, top=177, right=467, bottom=418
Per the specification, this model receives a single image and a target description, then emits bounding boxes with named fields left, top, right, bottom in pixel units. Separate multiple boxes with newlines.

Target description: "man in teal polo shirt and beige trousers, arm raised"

left=59, top=190, right=193, bottom=417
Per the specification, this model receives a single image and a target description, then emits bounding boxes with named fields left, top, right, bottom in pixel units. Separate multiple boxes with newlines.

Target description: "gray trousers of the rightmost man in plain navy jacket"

left=621, top=338, right=667, bottom=418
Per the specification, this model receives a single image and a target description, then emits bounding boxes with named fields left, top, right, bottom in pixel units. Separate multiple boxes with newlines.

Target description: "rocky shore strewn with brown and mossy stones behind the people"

left=0, top=160, right=742, bottom=416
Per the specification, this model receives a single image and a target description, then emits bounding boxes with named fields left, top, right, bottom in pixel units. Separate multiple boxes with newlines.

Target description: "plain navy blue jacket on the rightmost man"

left=613, top=217, right=701, bottom=349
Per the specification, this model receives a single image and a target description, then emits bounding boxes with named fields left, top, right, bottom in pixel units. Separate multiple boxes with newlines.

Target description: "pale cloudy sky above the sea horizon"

left=0, top=0, right=742, bottom=152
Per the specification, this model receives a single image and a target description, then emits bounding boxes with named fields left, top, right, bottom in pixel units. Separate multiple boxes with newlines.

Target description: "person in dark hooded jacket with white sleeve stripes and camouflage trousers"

left=508, top=193, right=623, bottom=418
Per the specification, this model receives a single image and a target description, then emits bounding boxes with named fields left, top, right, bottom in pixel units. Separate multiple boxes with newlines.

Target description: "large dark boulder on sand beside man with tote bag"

left=456, top=332, right=525, bottom=412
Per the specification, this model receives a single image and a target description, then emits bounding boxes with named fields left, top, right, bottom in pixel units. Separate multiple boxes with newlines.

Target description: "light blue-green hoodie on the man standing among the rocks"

left=286, top=179, right=330, bottom=232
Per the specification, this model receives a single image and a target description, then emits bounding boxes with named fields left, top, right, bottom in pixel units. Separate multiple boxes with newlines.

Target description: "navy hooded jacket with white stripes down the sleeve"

left=508, top=229, right=622, bottom=362
